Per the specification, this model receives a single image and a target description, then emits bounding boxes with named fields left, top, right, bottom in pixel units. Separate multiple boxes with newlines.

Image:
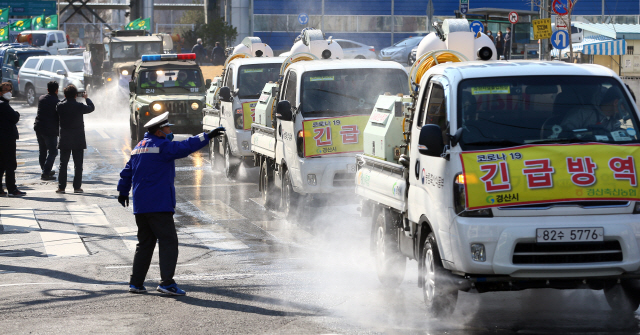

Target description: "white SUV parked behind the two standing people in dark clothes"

left=18, top=55, right=84, bottom=106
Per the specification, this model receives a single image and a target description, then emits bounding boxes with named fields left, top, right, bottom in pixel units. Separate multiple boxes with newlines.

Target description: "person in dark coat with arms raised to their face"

left=56, top=85, right=95, bottom=193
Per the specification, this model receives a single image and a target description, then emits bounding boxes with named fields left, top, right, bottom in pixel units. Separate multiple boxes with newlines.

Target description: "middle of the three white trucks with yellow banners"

left=251, top=57, right=409, bottom=218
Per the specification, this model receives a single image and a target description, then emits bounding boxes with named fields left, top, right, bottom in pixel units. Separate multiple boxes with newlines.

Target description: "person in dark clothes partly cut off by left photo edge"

left=0, top=82, right=27, bottom=197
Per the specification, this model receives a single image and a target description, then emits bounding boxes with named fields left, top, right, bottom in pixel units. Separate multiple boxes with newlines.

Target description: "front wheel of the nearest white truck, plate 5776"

left=422, top=233, right=458, bottom=317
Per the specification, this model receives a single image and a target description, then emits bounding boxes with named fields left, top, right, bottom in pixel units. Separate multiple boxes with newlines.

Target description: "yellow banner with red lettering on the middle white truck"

left=302, top=115, right=369, bottom=157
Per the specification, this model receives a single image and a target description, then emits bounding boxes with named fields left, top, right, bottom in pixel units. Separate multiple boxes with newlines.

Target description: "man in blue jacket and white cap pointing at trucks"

left=118, top=112, right=224, bottom=295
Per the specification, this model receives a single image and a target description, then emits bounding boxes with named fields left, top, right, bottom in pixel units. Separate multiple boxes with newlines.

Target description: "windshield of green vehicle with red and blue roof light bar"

left=137, top=68, right=204, bottom=94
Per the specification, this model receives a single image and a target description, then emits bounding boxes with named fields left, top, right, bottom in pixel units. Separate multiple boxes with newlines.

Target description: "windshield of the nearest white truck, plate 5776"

left=458, top=76, right=638, bottom=150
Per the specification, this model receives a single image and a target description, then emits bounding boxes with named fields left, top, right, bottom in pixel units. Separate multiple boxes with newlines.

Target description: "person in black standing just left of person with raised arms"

left=33, top=81, right=60, bottom=180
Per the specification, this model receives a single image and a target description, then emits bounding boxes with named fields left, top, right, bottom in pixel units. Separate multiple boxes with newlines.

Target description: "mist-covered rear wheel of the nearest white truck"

left=373, top=209, right=407, bottom=288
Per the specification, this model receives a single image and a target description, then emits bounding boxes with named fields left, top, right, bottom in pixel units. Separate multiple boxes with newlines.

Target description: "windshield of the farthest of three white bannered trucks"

left=238, top=63, right=282, bottom=99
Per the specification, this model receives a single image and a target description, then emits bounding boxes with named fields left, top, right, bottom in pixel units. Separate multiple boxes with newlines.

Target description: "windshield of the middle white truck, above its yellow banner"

left=300, top=69, right=409, bottom=117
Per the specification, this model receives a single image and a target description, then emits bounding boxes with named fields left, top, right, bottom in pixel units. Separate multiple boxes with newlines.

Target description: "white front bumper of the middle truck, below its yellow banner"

left=291, top=156, right=356, bottom=194
